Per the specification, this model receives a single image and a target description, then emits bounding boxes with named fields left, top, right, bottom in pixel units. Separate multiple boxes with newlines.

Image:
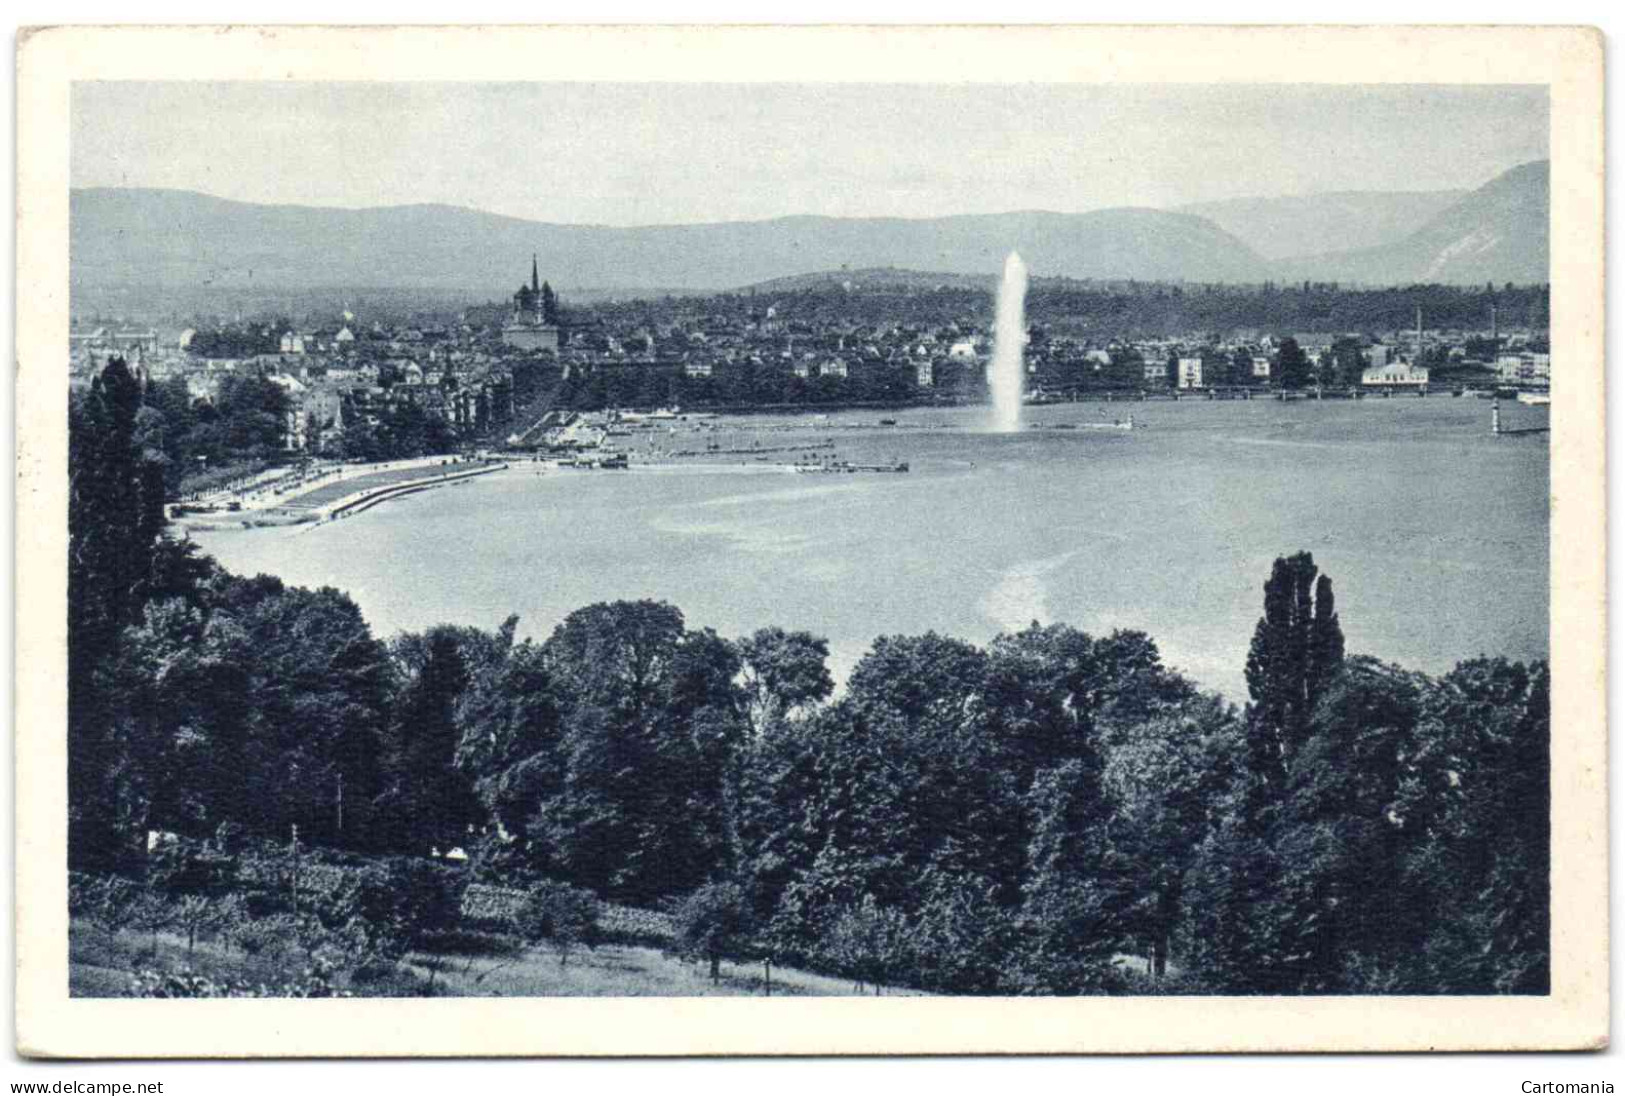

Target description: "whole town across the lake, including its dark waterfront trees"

left=68, top=266, right=1550, bottom=468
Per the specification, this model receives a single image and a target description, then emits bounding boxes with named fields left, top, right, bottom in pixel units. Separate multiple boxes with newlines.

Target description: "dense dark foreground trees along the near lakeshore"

left=68, top=356, right=1550, bottom=994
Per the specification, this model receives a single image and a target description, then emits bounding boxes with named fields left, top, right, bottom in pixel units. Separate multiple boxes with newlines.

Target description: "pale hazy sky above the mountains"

left=72, top=83, right=1547, bottom=224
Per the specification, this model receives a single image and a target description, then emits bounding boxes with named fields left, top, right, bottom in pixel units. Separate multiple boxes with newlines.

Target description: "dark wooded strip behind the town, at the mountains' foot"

left=73, top=272, right=1550, bottom=336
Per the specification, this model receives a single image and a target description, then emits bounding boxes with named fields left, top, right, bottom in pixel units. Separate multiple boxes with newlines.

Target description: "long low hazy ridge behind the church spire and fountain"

left=70, top=189, right=1266, bottom=296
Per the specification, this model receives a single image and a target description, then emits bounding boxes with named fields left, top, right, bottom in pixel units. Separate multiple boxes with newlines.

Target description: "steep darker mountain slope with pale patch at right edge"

left=1276, top=159, right=1552, bottom=285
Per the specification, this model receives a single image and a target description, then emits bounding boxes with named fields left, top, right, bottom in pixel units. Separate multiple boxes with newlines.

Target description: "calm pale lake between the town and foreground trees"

left=193, top=395, right=1550, bottom=702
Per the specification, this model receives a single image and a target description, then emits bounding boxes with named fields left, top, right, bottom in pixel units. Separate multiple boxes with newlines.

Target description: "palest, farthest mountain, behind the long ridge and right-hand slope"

left=1178, top=190, right=1469, bottom=260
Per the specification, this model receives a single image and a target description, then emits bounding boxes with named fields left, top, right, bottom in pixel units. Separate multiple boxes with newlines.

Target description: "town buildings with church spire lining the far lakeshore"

left=70, top=257, right=1550, bottom=450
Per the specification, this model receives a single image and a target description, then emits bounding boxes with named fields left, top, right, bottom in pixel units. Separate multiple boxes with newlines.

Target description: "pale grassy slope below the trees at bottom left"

left=68, top=922, right=918, bottom=997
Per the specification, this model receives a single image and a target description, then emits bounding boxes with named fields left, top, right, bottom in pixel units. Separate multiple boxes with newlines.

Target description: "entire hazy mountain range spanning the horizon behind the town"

left=70, top=163, right=1547, bottom=296
